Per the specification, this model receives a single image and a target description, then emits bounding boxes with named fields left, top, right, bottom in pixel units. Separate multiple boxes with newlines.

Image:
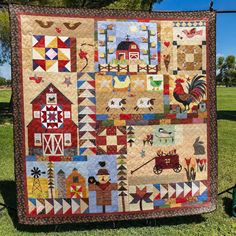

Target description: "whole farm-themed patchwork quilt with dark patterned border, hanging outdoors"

left=10, top=5, right=217, bottom=224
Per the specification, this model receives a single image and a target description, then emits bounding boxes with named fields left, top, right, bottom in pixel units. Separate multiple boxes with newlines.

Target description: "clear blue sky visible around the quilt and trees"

left=0, top=0, right=236, bottom=79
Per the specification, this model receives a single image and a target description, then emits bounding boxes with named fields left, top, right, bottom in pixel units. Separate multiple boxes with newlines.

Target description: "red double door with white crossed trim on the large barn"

left=43, top=134, right=64, bottom=156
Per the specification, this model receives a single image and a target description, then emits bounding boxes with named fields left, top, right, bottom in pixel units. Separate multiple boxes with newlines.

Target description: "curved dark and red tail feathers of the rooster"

left=187, top=75, right=206, bottom=102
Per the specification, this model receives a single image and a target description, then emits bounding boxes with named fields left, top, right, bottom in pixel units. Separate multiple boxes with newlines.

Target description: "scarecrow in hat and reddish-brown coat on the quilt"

left=88, top=162, right=117, bottom=213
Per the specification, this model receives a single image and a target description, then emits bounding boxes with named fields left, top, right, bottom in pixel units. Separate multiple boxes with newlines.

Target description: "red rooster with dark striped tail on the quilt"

left=173, top=75, right=206, bottom=111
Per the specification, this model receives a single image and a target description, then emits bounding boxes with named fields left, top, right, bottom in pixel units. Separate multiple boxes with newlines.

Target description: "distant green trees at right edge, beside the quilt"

left=216, top=55, right=236, bottom=87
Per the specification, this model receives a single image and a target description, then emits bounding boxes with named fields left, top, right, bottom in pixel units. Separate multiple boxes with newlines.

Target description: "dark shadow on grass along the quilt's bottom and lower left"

left=0, top=181, right=205, bottom=233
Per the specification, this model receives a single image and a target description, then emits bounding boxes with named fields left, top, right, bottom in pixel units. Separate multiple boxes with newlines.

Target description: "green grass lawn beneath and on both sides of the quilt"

left=0, top=88, right=236, bottom=236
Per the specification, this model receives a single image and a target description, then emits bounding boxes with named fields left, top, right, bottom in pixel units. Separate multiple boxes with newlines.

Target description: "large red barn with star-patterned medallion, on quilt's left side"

left=27, top=84, right=77, bottom=159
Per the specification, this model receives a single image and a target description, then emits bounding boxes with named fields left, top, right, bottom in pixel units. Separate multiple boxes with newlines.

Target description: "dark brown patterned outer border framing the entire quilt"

left=10, top=5, right=217, bottom=225
